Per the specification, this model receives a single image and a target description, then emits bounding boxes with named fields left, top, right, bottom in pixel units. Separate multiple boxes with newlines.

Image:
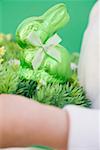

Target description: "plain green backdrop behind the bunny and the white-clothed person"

left=0, top=0, right=96, bottom=52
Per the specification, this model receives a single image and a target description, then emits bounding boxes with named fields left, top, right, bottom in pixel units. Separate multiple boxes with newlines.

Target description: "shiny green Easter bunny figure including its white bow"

left=16, top=4, right=71, bottom=83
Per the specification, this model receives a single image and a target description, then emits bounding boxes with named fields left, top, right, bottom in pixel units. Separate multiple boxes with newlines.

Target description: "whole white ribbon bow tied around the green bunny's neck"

left=28, top=31, right=62, bottom=69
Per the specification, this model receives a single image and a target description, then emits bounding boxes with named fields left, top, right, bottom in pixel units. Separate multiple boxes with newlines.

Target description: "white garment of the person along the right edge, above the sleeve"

left=78, top=1, right=100, bottom=108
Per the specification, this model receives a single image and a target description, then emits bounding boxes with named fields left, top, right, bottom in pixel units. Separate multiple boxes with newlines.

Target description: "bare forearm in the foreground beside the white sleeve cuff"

left=0, top=95, right=69, bottom=150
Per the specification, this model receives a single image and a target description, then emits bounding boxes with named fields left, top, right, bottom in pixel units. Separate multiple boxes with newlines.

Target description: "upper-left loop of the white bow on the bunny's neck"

left=28, top=31, right=42, bottom=46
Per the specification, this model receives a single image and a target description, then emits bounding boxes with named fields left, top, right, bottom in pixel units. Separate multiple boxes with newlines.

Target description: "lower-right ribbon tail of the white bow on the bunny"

left=46, top=47, right=61, bottom=63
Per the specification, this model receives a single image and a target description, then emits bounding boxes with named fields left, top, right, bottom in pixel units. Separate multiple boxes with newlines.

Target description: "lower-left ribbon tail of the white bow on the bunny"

left=32, top=49, right=45, bottom=69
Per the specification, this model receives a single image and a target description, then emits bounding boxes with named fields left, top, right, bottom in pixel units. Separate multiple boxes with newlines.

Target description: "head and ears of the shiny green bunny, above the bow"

left=16, top=3, right=69, bottom=48
